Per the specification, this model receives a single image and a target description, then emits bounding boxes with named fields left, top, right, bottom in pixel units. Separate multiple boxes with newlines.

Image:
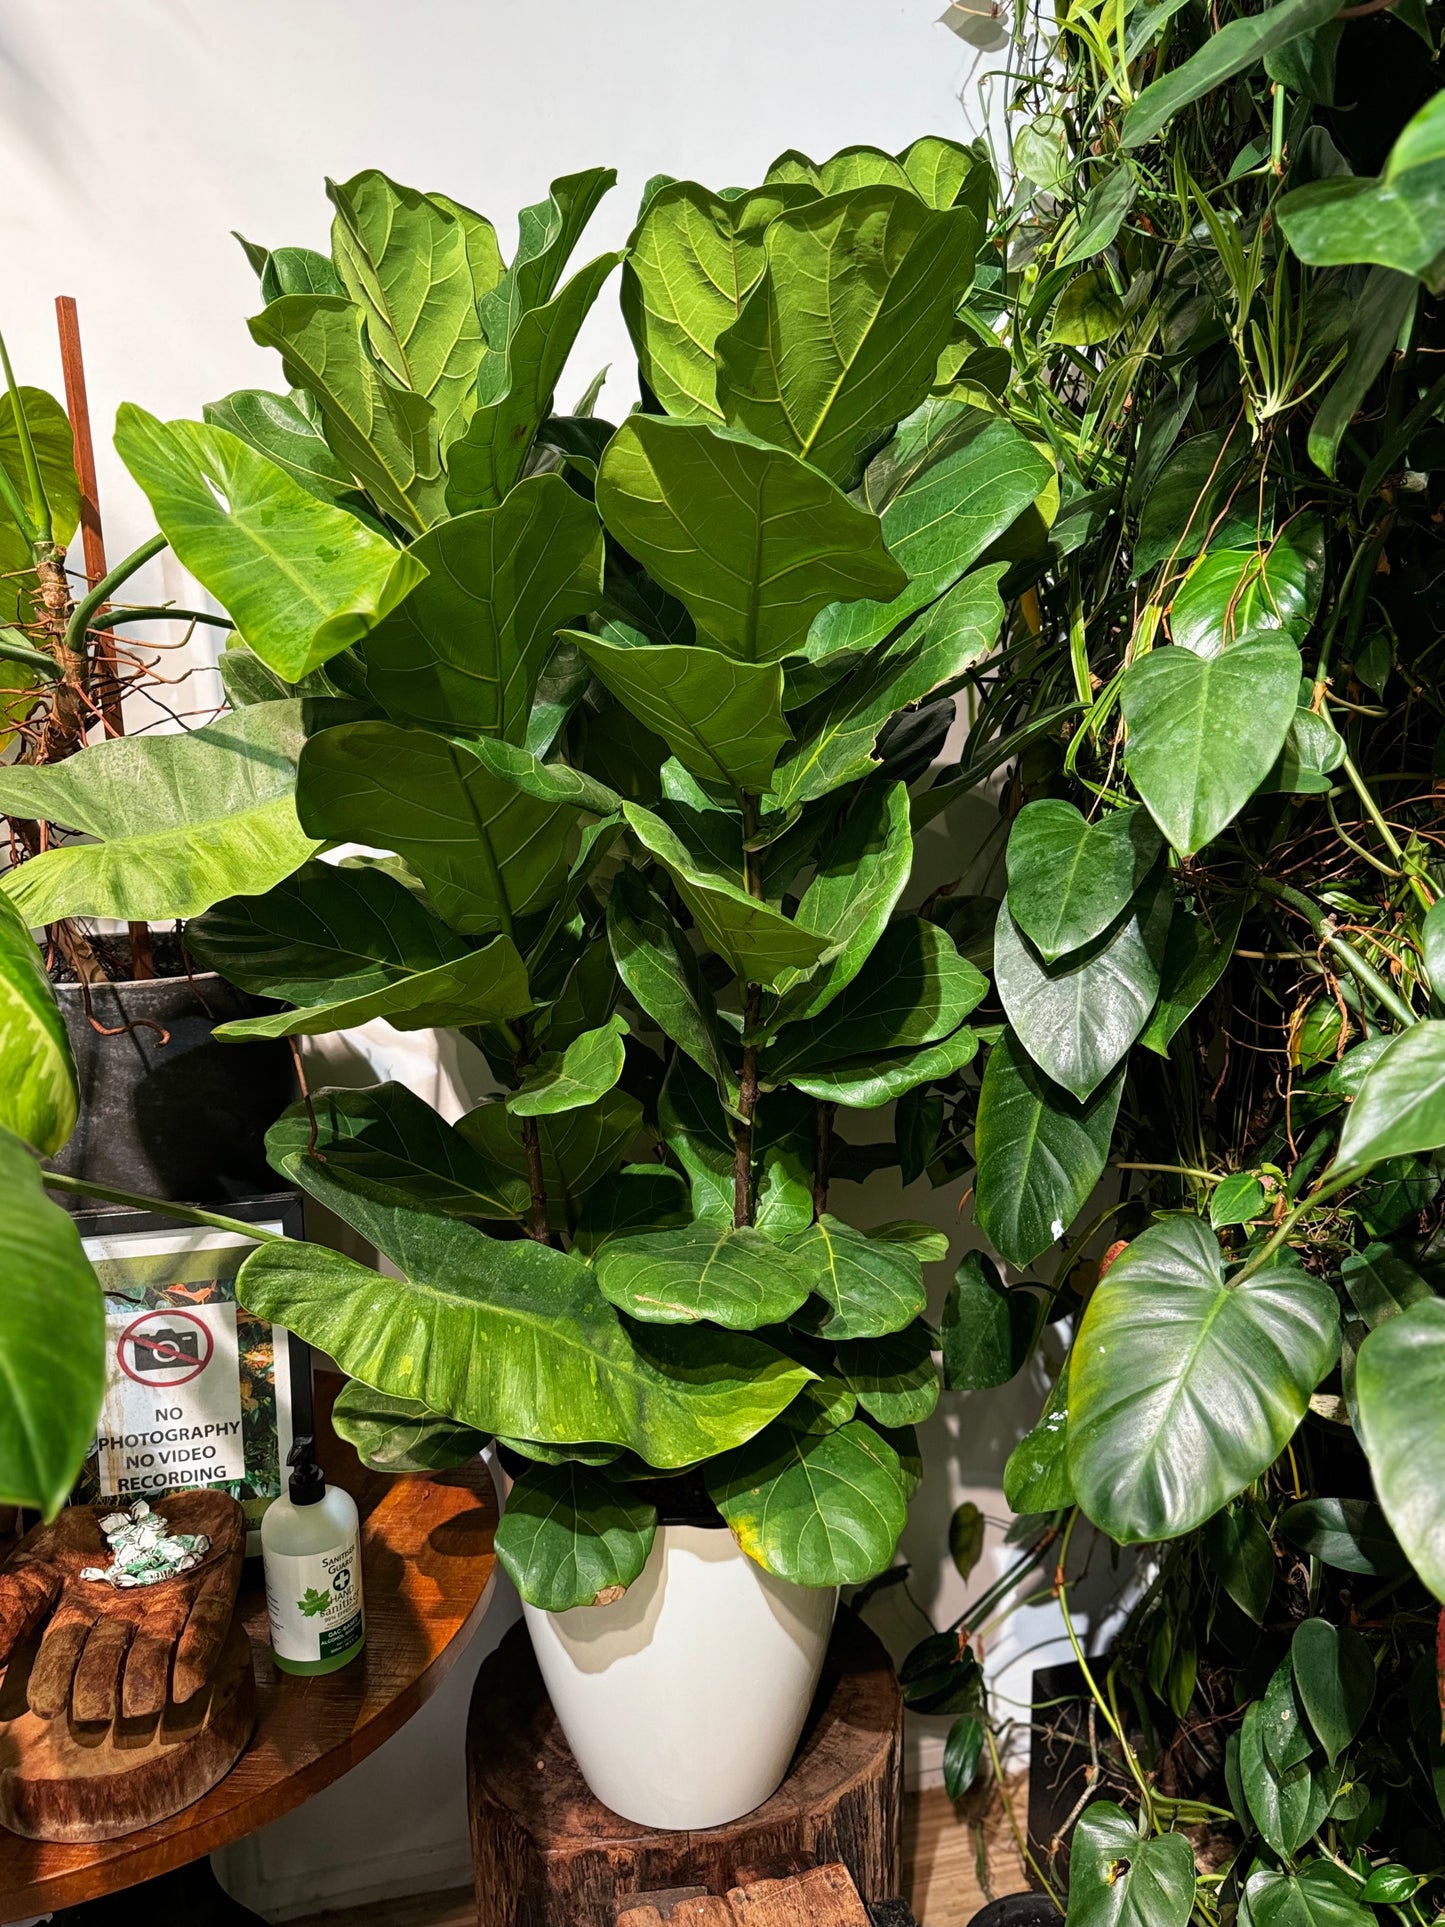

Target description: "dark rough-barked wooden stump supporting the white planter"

left=466, top=1611, right=904, bottom=1927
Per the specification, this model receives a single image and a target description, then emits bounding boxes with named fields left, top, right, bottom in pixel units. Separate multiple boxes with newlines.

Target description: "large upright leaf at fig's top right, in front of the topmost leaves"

left=717, top=185, right=979, bottom=488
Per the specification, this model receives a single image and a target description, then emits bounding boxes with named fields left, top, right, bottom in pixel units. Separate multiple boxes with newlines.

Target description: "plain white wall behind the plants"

left=0, top=0, right=1117, bottom=1914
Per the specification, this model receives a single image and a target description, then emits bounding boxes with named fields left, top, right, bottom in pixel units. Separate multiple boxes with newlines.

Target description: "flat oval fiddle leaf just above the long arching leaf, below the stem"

left=597, top=1222, right=813, bottom=1332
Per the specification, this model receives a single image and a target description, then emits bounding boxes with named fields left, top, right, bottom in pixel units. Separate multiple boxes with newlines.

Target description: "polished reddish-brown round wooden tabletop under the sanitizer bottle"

left=0, top=1374, right=497, bottom=1921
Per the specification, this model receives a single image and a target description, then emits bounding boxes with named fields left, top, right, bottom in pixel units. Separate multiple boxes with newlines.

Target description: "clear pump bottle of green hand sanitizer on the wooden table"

left=260, top=1438, right=366, bottom=1673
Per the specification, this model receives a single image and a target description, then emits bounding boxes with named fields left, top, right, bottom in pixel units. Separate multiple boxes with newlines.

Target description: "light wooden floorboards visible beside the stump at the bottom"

left=291, top=1777, right=1029, bottom=1927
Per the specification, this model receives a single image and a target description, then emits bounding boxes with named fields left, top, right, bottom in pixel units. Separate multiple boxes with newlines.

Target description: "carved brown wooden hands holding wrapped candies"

left=0, top=1491, right=247, bottom=1721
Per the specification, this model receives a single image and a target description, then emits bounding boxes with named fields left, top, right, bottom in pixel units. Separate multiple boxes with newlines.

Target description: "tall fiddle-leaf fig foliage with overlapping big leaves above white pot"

left=0, top=139, right=1054, bottom=1609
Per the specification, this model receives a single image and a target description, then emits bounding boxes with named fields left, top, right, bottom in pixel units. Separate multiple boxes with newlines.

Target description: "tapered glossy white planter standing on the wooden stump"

left=522, top=1526, right=838, bottom=1829
